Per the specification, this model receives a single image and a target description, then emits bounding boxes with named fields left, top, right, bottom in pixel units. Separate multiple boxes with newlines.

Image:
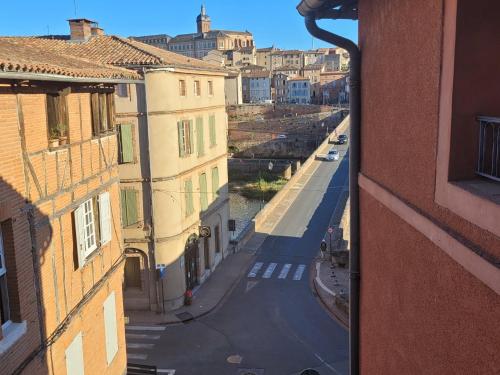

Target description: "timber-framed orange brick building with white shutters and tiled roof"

left=0, top=38, right=140, bottom=374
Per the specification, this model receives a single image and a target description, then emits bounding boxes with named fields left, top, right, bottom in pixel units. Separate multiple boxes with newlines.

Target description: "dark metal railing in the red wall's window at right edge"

left=476, top=116, right=500, bottom=182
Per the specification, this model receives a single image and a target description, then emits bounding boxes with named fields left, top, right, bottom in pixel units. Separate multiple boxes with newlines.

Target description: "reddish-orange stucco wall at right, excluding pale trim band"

left=359, top=0, right=500, bottom=375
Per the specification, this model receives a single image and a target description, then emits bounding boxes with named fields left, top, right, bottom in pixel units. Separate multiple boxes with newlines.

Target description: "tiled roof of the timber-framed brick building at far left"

left=0, top=37, right=141, bottom=79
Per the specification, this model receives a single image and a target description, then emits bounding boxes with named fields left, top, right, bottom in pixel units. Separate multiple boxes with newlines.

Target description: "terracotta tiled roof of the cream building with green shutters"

left=1, top=35, right=222, bottom=71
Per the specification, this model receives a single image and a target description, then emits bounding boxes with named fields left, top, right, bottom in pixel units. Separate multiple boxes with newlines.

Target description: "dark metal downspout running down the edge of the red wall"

left=305, top=15, right=361, bottom=375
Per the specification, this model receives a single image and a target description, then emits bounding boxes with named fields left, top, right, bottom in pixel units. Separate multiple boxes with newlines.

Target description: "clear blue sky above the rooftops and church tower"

left=0, top=0, right=357, bottom=49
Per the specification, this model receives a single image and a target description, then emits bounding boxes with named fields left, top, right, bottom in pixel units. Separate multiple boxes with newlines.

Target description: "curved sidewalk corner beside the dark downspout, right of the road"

left=311, top=255, right=349, bottom=328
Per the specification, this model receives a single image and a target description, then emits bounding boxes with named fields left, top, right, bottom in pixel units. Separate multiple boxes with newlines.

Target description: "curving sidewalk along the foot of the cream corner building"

left=125, top=249, right=255, bottom=325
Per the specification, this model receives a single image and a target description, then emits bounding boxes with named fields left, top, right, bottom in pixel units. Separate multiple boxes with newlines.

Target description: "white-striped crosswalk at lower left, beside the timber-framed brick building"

left=125, top=325, right=165, bottom=361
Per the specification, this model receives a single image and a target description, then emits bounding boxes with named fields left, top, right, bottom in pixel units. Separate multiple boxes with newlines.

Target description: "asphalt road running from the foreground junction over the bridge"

left=130, top=140, right=348, bottom=375
